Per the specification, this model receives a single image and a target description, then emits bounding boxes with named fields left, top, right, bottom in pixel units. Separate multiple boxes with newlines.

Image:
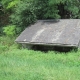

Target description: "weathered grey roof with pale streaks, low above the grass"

left=16, top=19, right=80, bottom=47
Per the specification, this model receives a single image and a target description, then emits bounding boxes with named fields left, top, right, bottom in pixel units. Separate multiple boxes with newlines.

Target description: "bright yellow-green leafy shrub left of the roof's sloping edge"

left=3, top=25, right=16, bottom=36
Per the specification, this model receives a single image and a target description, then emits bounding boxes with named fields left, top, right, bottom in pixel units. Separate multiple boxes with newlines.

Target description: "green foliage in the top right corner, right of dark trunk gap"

left=64, top=0, right=80, bottom=18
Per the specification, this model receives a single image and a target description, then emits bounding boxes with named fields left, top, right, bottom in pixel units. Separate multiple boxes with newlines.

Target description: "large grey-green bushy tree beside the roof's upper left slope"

left=10, top=0, right=36, bottom=30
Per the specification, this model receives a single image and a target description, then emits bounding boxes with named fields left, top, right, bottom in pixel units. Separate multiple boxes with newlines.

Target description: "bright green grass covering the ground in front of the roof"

left=0, top=36, right=80, bottom=80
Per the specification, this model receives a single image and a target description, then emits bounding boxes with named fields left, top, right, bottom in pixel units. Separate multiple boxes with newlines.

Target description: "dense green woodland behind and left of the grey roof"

left=0, top=0, right=80, bottom=36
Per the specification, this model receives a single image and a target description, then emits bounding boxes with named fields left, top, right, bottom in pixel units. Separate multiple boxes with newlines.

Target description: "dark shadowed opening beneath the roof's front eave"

left=31, top=45, right=78, bottom=53
